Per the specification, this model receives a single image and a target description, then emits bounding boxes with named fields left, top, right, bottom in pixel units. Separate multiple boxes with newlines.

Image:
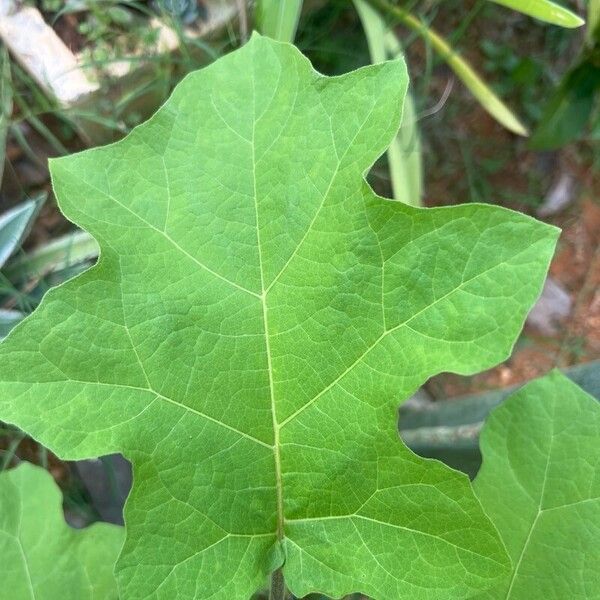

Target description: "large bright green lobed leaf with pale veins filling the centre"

left=0, top=36, right=556, bottom=600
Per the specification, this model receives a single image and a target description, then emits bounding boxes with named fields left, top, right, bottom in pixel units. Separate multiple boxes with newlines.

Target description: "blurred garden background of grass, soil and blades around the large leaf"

left=0, top=0, right=600, bottom=596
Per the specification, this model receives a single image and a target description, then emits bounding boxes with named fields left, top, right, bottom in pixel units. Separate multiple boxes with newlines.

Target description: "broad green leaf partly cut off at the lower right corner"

left=474, top=371, right=600, bottom=600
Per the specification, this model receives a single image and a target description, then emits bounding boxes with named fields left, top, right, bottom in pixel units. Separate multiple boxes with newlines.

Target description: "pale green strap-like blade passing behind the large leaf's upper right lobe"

left=354, top=0, right=422, bottom=206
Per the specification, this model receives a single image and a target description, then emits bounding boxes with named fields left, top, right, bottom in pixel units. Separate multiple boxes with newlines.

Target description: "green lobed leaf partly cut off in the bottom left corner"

left=0, top=463, right=124, bottom=600
